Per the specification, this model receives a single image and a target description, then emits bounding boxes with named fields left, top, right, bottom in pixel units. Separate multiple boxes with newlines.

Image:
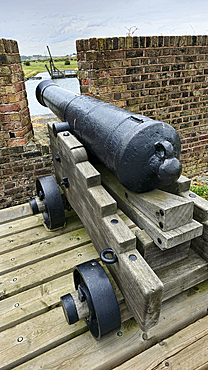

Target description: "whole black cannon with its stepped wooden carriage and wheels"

left=30, top=80, right=202, bottom=340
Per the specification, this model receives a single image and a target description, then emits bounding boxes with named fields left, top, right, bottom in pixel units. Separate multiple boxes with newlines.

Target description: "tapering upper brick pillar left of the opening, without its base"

left=0, top=39, right=33, bottom=148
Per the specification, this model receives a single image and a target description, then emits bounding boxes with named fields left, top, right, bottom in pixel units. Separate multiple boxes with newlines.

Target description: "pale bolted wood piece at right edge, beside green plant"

left=180, top=191, right=208, bottom=222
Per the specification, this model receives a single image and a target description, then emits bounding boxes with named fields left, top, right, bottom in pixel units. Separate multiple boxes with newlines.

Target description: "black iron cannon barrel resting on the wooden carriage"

left=36, top=80, right=182, bottom=193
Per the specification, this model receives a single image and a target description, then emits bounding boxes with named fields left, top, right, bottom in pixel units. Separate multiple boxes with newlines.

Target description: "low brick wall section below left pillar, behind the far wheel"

left=0, top=142, right=54, bottom=209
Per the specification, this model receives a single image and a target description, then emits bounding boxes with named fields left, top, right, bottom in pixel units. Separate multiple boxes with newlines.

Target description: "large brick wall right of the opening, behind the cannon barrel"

left=76, top=36, right=208, bottom=177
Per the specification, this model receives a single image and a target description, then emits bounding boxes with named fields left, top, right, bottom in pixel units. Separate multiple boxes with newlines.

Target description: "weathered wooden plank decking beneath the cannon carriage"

left=0, top=204, right=208, bottom=370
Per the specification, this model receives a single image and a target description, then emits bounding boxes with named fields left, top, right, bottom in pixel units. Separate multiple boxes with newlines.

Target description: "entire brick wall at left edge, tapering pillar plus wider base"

left=0, top=39, right=53, bottom=209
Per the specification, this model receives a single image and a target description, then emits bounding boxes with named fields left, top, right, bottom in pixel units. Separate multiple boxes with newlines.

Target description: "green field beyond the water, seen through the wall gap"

left=22, top=58, right=77, bottom=79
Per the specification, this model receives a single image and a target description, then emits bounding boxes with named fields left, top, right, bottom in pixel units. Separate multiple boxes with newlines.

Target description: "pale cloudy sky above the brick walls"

left=0, top=0, right=208, bottom=56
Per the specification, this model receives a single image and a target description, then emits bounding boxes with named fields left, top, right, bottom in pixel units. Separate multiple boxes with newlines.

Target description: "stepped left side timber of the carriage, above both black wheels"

left=48, top=124, right=163, bottom=330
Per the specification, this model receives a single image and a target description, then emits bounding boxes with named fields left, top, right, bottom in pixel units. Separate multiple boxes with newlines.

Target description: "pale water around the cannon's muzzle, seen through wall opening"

left=25, top=72, right=80, bottom=116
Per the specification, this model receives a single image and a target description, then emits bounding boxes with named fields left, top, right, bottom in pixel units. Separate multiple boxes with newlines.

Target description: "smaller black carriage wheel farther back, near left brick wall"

left=36, top=175, right=65, bottom=230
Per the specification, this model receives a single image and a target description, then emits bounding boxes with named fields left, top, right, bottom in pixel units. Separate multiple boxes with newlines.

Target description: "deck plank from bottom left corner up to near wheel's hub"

left=0, top=307, right=87, bottom=369
